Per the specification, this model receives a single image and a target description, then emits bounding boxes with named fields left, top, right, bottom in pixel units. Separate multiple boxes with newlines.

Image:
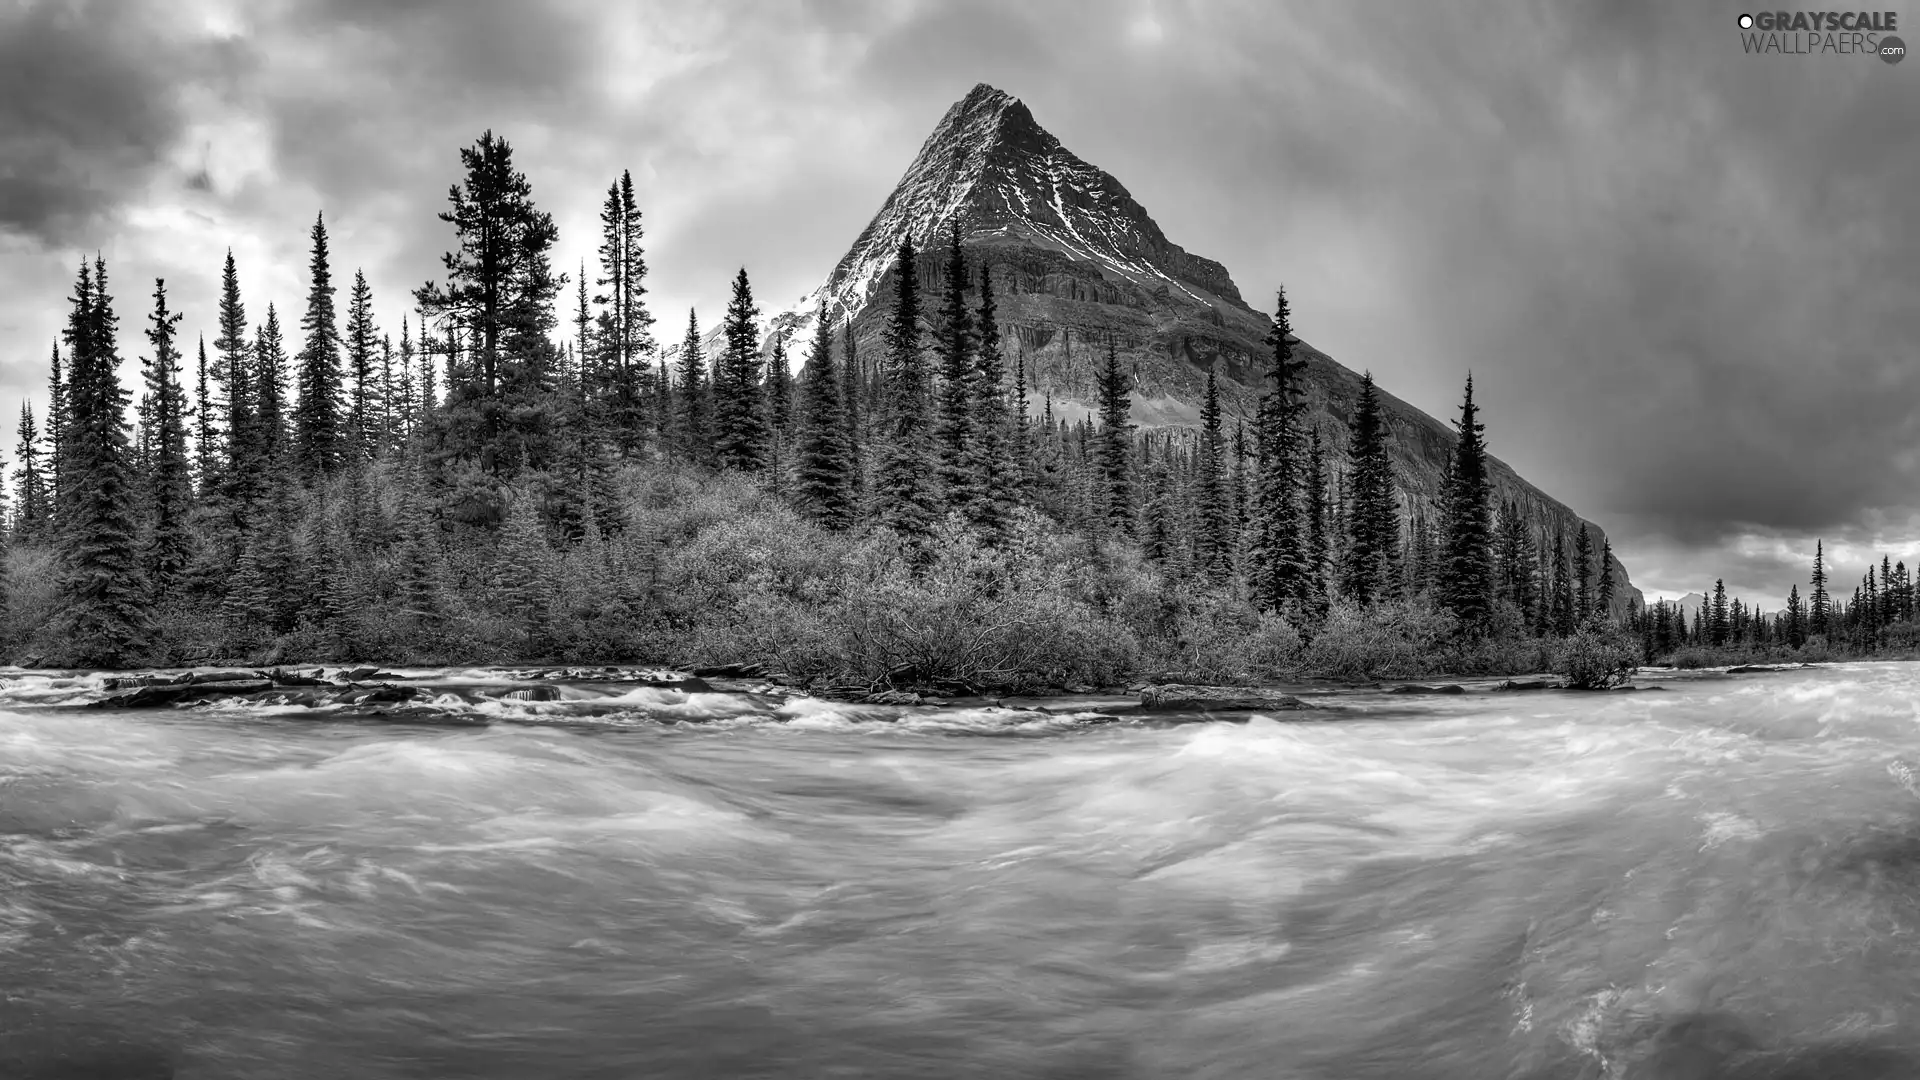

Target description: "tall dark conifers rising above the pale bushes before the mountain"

left=8, top=123, right=1635, bottom=667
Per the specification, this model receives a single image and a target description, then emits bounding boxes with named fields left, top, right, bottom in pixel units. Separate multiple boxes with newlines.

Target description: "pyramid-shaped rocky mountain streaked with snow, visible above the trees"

left=702, top=85, right=1642, bottom=613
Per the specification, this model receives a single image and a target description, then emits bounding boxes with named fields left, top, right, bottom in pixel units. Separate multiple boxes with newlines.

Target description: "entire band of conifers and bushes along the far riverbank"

left=6, top=133, right=1920, bottom=690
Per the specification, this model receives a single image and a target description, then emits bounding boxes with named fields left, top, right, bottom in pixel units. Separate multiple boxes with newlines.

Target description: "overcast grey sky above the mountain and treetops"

left=0, top=0, right=1920, bottom=605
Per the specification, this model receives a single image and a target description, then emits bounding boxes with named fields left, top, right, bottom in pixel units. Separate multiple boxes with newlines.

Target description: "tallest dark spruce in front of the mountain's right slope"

left=1250, top=290, right=1308, bottom=611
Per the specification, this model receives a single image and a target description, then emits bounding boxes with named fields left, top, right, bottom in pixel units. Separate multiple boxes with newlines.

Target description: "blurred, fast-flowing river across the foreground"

left=0, top=665, right=1920, bottom=1080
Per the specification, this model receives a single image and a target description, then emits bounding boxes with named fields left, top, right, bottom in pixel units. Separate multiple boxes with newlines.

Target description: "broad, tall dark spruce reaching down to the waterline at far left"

left=60, top=256, right=152, bottom=667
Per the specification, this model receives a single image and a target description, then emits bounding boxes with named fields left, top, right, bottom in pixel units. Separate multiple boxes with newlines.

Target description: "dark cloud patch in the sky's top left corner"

left=0, top=0, right=198, bottom=244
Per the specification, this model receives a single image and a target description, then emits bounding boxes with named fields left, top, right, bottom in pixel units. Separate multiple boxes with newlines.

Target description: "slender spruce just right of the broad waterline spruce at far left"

left=140, top=279, right=194, bottom=601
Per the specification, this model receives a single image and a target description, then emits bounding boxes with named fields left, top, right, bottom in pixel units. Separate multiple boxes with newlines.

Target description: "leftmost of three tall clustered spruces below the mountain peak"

left=874, top=238, right=939, bottom=540
